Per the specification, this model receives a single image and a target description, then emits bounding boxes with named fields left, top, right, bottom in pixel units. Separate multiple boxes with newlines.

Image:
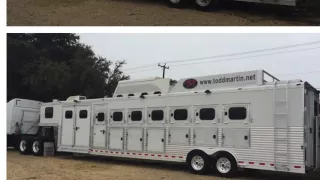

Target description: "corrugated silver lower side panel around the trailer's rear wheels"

left=166, top=127, right=304, bottom=173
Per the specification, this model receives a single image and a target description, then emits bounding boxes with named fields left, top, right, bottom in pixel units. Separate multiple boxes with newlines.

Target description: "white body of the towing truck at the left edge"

left=7, top=98, right=41, bottom=149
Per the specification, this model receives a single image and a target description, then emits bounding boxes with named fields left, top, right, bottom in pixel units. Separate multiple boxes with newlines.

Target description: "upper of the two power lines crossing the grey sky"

left=126, top=41, right=320, bottom=71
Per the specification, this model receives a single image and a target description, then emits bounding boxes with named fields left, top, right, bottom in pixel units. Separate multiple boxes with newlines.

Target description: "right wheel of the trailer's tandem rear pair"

left=213, top=153, right=237, bottom=177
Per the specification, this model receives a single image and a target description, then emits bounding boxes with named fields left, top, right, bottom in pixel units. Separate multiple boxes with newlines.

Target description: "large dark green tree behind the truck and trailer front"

left=7, top=34, right=130, bottom=102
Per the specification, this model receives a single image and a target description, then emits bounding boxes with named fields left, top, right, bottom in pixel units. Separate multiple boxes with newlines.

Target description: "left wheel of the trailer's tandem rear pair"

left=187, top=151, right=211, bottom=174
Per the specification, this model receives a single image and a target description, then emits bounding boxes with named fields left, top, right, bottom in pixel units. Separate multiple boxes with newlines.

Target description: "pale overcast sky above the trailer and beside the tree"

left=78, top=33, right=320, bottom=88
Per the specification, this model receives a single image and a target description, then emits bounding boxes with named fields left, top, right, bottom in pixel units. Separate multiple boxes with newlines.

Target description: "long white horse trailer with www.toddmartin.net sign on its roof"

left=18, top=70, right=320, bottom=176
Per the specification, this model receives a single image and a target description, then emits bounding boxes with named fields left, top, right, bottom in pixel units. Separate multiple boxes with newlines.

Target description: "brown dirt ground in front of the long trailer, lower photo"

left=7, top=150, right=320, bottom=180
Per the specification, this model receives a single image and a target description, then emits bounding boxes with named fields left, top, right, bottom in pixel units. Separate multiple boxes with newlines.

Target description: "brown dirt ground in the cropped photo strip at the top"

left=7, top=0, right=320, bottom=26
